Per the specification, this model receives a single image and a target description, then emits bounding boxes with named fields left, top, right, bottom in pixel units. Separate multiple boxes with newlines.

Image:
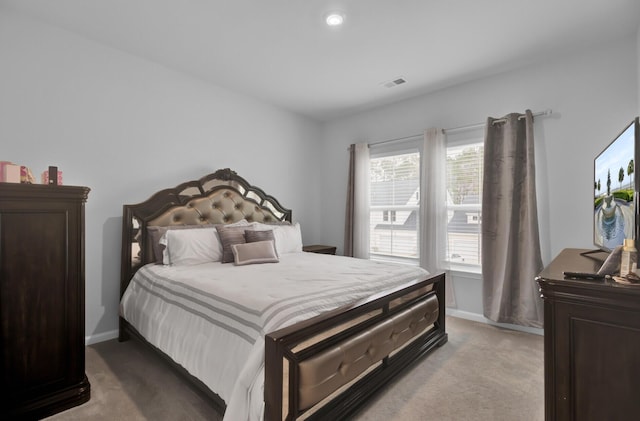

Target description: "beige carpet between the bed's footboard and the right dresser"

left=358, top=317, right=544, bottom=421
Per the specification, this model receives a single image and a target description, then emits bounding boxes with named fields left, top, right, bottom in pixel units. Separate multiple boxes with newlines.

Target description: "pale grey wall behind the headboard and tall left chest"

left=0, top=8, right=320, bottom=341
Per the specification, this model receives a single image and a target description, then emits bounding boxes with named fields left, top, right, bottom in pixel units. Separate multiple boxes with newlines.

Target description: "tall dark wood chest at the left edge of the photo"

left=0, top=183, right=90, bottom=419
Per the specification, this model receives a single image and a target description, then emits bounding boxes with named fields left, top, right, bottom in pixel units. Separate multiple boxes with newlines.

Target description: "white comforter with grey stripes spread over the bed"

left=120, top=253, right=427, bottom=421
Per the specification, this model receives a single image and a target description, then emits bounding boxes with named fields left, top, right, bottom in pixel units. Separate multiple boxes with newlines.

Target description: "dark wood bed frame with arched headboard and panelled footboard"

left=119, top=169, right=447, bottom=421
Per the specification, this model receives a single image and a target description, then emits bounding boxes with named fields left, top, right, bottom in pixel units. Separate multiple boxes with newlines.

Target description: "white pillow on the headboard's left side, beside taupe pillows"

left=160, top=229, right=222, bottom=266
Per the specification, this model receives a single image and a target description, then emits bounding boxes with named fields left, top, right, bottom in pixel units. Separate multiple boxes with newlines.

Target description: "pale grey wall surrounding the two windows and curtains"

left=322, top=35, right=639, bottom=314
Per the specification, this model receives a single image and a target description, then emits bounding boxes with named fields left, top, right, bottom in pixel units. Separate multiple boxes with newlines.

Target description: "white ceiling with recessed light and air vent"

left=0, top=0, right=640, bottom=121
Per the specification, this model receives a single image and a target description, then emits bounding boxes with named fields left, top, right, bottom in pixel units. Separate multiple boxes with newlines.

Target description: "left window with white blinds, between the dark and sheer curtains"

left=369, top=152, right=420, bottom=265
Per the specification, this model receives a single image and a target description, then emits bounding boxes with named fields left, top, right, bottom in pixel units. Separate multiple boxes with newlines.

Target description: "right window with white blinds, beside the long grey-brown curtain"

left=447, top=139, right=484, bottom=266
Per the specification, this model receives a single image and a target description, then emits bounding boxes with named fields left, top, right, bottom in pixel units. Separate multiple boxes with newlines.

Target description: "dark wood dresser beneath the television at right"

left=537, top=249, right=640, bottom=421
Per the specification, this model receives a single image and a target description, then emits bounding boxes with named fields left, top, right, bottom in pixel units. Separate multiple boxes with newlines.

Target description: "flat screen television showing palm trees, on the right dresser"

left=593, top=117, right=640, bottom=251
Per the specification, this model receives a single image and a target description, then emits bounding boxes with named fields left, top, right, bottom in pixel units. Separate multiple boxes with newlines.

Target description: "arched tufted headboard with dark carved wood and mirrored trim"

left=120, top=168, right=291, bottom=295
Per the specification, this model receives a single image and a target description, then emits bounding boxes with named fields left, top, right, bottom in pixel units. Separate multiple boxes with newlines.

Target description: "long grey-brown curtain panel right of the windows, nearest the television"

left=482, top=110, right=543, bottom=328
